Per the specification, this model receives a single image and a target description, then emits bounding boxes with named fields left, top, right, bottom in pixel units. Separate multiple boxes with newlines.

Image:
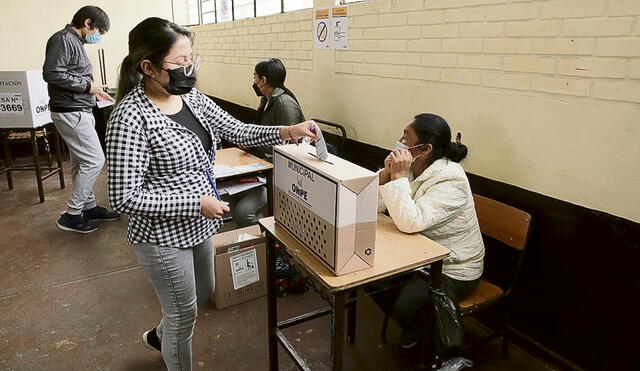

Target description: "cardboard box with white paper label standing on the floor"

left=213, top=225, right=267, bottom=309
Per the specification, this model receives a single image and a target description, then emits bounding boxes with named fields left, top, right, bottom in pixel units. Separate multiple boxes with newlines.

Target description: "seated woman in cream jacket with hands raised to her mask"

left=378, top=113, right=484, bottom=348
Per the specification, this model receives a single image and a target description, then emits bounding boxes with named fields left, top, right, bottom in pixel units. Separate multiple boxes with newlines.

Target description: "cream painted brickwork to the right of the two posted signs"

left=335, top=0, right=640, bottom=103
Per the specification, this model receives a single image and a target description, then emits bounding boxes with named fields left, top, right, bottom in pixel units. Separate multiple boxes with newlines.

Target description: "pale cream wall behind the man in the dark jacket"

left=0, top=0, right=172, bottom=86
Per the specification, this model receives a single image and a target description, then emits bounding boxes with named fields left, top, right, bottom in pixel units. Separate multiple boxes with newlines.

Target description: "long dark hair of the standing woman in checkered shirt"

left=116, top=17, right=193, bottom=101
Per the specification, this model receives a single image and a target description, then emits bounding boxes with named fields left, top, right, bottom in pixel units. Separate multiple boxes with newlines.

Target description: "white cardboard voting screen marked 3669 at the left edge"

left=0, top=70, right=51, bottom=128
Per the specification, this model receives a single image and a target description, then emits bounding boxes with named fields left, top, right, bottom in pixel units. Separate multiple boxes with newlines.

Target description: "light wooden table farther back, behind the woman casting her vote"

left=214, top=147, right=273, bottom=215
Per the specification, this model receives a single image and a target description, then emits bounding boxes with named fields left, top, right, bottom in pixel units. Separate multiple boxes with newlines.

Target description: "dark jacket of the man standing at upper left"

left=42, top=25, right=96, bottom=112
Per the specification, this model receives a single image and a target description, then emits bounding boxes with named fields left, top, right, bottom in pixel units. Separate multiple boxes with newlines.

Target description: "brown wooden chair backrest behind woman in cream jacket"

left=473, top=194, right=531, bottom=251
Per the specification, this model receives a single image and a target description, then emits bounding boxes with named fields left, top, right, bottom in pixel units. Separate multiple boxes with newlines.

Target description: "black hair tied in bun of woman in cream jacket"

left=411, top=113, right=469, bottom=162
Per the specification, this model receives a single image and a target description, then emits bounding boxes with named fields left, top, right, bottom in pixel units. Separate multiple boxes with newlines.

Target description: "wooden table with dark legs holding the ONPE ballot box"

left=259, top=214, right=449, bottom=371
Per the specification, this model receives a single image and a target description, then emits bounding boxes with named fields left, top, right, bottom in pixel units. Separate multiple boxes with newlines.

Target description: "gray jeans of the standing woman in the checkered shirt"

left=133, top=238, right=215, bottom=371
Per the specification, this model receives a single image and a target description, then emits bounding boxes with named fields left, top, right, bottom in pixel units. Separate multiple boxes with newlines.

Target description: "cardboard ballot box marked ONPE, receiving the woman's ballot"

left=273, top=144, right=378, bottom=276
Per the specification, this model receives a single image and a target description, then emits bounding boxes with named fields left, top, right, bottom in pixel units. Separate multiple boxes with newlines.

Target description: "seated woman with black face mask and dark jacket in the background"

left=229, top=58, right=305, bottom=227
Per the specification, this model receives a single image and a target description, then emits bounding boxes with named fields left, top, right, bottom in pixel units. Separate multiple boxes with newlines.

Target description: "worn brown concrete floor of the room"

left=0, top=162, right=558, bottom=371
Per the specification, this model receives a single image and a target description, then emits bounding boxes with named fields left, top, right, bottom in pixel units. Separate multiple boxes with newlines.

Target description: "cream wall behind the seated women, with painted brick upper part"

left=193, top=0, right=640, bottom=222
